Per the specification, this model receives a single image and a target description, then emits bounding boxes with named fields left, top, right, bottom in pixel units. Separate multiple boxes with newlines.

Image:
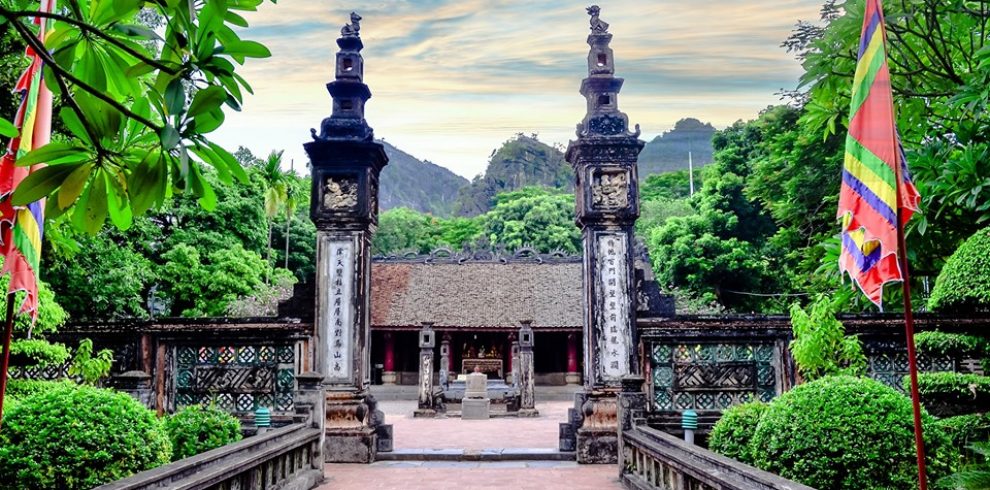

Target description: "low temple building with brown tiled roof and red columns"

left=358, top=249, right=672, bottom=385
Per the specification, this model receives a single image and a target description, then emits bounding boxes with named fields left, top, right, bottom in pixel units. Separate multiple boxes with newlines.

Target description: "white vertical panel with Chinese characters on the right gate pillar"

left=595, top=233, right=632, bottom=381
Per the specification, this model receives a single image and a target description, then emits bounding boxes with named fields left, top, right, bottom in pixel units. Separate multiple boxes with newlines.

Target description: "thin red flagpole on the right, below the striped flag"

left=894, top=161, right=928, bottom=490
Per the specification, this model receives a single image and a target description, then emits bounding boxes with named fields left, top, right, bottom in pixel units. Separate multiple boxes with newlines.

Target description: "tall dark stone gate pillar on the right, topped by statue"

left=562, top=6, right=645, bottom=463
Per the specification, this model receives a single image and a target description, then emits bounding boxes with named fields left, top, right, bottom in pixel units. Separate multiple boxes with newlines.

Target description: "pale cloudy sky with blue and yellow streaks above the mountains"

left=214, top=0, right=822, bottom=178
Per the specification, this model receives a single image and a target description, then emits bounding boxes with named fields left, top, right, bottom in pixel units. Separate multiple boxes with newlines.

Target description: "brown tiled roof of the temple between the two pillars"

left=371, top=249, right=583, bottom=330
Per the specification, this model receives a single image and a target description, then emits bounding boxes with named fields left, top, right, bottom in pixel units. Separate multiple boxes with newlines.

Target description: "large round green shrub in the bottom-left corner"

left=0, top=384, right=172, bottom=490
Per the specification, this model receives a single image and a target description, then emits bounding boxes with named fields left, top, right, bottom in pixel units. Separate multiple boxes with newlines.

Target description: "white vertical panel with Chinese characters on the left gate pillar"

left=325, top=240, right=354, bottom=381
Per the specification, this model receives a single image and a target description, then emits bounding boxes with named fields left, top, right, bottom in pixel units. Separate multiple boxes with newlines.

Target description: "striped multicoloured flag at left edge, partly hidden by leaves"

left=0, top=0, right=55, bottom=318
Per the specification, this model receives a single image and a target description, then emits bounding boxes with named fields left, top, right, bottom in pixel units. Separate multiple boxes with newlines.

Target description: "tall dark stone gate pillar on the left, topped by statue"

left=303, top=13, right=388, bottom=463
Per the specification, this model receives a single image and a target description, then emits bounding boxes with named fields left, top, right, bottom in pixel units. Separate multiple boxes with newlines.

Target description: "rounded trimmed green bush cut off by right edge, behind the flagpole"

left=928, top=228, right=990, bottom=311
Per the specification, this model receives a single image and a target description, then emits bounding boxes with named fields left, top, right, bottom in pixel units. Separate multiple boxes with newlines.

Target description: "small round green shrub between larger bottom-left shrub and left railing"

left=165, top=405, right=241, bottom=461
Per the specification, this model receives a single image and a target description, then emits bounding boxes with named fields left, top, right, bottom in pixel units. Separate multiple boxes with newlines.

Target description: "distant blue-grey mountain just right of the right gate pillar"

left=639, top=117, right=715, bottom=179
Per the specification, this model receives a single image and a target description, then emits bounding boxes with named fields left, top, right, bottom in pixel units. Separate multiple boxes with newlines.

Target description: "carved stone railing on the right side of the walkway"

left=619, top=425, right=814, bottom=490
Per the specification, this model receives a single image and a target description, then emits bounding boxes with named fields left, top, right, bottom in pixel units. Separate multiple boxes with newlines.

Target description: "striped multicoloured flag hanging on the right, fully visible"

left=839, top=0, right=920, bottom=307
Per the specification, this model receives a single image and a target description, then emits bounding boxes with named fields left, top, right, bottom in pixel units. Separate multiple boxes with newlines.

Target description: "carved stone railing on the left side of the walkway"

left=97, top=423, right=323, bottom=490
